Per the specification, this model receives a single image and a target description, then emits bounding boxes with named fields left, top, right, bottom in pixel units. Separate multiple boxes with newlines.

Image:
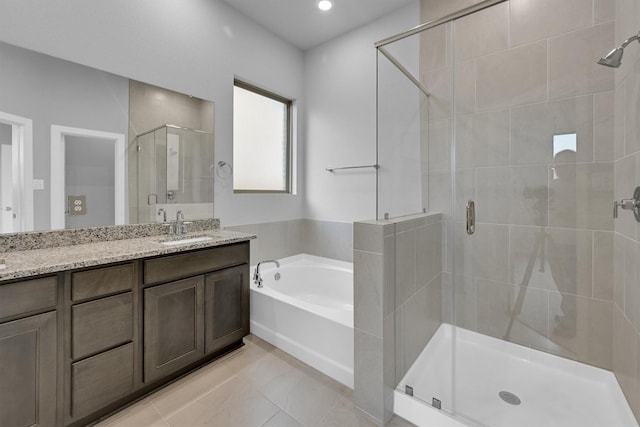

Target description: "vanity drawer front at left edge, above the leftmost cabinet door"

left=0, top=276, right=58, bottom=321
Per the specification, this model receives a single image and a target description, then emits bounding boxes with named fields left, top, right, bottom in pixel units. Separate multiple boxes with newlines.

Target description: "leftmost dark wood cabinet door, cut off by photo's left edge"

left=0, top=312, right=57, bottom=427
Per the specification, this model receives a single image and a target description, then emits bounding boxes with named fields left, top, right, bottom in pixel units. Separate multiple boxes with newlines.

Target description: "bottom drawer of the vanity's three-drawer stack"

left=70, top=343, right=134, bottom=419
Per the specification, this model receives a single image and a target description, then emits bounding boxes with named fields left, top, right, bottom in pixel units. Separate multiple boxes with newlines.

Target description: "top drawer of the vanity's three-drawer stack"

left=71, top=263, right=135, bottom=301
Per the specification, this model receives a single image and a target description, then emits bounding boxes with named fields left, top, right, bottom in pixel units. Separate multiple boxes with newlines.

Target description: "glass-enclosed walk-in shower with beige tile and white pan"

left=372, top=0, right=640, bottom=427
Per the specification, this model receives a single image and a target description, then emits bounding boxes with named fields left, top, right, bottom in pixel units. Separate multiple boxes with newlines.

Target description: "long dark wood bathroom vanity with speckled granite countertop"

left=0, top=226, right=252, bottom=427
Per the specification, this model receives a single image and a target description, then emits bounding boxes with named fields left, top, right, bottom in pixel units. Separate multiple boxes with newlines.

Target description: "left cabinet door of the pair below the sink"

left=144, top=276, right=204, bottom=383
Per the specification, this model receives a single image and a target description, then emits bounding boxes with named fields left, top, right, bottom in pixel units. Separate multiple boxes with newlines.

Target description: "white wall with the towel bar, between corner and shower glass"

left=304, top=1, right=420, bottom=222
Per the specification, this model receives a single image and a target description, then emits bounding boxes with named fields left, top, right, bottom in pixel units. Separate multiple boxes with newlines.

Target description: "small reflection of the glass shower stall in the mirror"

left=130, top=125, right=214, bottom=223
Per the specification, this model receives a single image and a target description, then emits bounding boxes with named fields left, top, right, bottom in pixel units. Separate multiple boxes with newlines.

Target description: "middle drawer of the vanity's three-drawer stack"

left=71, top=292, right=133, bottom=359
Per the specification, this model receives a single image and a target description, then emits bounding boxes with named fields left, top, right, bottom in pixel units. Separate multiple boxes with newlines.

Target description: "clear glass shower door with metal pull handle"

left=450, top=2, right=614, bottom=426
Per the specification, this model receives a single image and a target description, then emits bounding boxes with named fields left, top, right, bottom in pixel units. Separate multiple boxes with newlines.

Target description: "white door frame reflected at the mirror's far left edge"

left=0, top=111, right=33, bottom=231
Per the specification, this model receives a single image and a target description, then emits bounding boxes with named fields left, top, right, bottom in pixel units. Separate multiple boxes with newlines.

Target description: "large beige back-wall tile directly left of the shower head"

left=549, top=21, right=615, bottom=99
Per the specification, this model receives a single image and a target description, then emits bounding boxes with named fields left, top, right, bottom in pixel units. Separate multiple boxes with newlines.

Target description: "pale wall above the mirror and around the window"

left=0, top=0, right=304, bottom=225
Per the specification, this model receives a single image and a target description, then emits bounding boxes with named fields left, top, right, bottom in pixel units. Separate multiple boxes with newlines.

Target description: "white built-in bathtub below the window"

left=251, top=254, right=353, bottom=388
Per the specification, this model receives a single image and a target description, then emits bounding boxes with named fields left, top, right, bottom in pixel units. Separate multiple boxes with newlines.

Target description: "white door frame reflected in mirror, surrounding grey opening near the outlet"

left=51, top=125, right=126, bottom=230
